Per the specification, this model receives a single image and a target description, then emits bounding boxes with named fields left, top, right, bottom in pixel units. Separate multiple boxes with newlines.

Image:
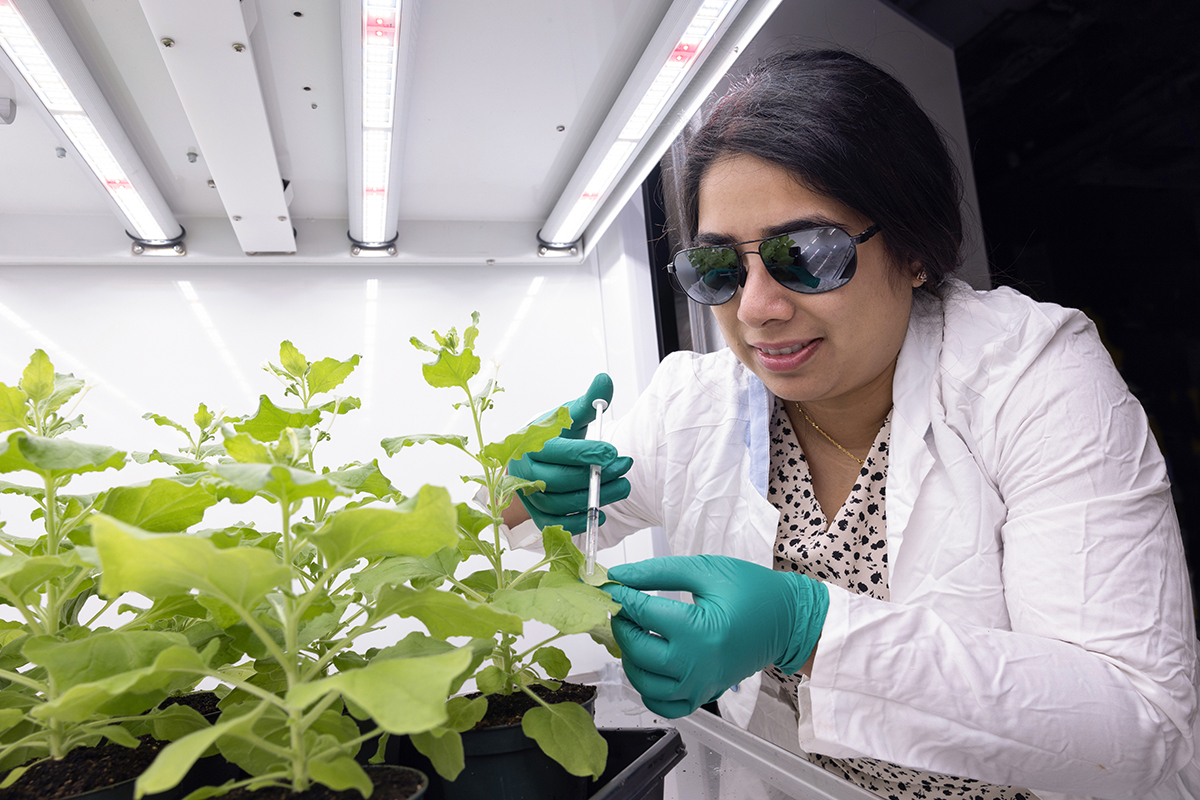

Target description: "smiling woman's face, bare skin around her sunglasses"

left=697, top=155, right=920, bottom=405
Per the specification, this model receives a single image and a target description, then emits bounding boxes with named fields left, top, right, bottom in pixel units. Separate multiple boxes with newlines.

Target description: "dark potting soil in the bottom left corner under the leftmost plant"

left=0, top=736, right=169, bottom=800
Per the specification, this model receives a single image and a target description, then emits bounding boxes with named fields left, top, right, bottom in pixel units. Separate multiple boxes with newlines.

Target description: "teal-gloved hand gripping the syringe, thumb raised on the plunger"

left=509, top=373, right=634, bottom=534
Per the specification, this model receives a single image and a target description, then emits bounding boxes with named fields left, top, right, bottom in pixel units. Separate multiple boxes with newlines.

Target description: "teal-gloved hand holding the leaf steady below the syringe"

left=602, top=555, right=829, bottom=720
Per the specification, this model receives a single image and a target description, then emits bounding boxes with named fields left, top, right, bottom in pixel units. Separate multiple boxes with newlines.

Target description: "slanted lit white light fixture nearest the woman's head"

left=538, top=0, right=782, bottom=257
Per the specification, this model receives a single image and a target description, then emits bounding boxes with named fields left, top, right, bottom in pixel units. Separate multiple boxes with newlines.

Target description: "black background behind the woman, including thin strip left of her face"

left=646, top=0, right=1200, bottom=597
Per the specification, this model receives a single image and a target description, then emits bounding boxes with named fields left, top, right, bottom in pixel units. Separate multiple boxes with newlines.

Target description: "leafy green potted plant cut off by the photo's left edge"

left=0, top=350, right=216, bottom=788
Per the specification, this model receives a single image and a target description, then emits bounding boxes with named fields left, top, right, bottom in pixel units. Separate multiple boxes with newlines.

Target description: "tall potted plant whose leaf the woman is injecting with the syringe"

left=379, top=314, right=620, bottom=794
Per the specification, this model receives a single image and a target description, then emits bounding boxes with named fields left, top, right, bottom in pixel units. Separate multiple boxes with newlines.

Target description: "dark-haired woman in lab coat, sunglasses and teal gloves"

left=511, top=52, right=1196, bottom=798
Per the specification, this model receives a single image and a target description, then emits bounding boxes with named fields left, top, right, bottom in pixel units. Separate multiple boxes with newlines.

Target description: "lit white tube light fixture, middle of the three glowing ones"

left=342, top=0, right=418, bottom=257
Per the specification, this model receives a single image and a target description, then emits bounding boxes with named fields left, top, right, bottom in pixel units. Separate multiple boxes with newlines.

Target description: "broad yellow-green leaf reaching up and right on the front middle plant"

left=310, top=486, right=458, bottom=565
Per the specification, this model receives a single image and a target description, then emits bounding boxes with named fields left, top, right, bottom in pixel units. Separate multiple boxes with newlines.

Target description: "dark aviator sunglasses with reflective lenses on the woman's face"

left=667, top=225, right=880, bottom=306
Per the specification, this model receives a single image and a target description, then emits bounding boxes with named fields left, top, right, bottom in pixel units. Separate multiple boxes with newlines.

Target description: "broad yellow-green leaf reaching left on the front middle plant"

left=91, top=515, right=292, bottom=610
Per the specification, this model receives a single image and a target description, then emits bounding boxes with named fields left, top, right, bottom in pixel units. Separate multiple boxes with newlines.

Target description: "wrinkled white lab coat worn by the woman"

left=590, top=283, right=1200, bottom=800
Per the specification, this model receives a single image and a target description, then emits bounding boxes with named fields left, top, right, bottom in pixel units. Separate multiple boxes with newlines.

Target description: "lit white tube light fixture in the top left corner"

left=0, top=0, right=184, bottom=250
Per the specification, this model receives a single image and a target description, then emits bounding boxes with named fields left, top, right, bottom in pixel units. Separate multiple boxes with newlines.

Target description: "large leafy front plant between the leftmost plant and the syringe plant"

left=81, top=342, right=494, bottom=798
